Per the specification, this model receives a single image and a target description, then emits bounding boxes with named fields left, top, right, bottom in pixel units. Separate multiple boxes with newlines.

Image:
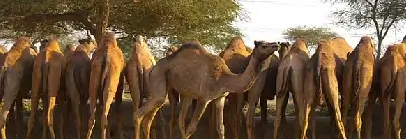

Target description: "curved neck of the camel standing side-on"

left=221, top=56, right=260, bottom=93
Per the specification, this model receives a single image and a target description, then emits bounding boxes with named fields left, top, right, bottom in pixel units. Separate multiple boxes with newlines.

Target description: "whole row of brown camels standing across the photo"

left=0, top=32, right=406, bottom=139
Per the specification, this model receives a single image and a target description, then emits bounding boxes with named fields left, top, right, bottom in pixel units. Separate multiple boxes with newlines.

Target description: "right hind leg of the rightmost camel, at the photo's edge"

left=393, top=77, right=406, bottom=139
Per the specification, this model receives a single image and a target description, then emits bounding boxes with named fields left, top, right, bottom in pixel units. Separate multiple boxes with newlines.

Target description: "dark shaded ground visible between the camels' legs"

left=3, top=100, right=406, bottom=139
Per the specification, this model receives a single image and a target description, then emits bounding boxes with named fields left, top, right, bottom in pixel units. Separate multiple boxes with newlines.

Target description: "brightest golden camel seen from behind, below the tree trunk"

left=87, top=32, right=124, bottom=139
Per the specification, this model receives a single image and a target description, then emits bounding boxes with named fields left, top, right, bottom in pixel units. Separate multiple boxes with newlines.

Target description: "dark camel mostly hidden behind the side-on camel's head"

left=246, top=42, right=291, bottom=139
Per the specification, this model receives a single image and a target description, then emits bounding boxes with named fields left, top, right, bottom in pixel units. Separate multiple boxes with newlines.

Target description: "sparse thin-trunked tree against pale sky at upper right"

left=326, top=0, right=406, bottom=59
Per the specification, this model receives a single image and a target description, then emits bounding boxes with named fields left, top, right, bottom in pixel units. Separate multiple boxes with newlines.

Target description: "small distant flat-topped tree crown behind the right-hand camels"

left=283, top=26, right=337, bottom=46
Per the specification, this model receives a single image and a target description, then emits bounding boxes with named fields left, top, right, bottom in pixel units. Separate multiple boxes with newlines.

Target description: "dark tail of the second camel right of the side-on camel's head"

left=313, top=53, right=324, bottom=105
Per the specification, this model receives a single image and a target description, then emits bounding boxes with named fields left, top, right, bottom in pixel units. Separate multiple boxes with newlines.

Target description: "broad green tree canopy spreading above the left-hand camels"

left=0, top=0, right=243, bottom=47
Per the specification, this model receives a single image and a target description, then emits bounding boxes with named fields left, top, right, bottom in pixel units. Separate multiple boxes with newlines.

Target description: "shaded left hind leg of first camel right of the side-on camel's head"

left=273, top=92, right=287, bottom=139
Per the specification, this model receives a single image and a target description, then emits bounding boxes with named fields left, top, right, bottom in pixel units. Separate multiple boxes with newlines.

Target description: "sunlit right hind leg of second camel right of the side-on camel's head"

left=322, top=68, right=346, bottom=139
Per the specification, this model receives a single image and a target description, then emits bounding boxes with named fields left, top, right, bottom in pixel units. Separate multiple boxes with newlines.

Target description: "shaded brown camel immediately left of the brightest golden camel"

left=65, top=39, right=95, bottom=139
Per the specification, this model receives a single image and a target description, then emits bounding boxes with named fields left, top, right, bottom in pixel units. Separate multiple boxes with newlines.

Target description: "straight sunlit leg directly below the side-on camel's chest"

left=214, top=97, right=225, bottom=139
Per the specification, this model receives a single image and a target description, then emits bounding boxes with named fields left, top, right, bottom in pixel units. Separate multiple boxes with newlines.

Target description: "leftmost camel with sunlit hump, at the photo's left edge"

left=0, top=37, right=36, bottom=139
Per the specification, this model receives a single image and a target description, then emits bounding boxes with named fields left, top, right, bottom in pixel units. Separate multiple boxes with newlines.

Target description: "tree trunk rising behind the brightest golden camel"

left=94, top=0, right=110, bottom=44
